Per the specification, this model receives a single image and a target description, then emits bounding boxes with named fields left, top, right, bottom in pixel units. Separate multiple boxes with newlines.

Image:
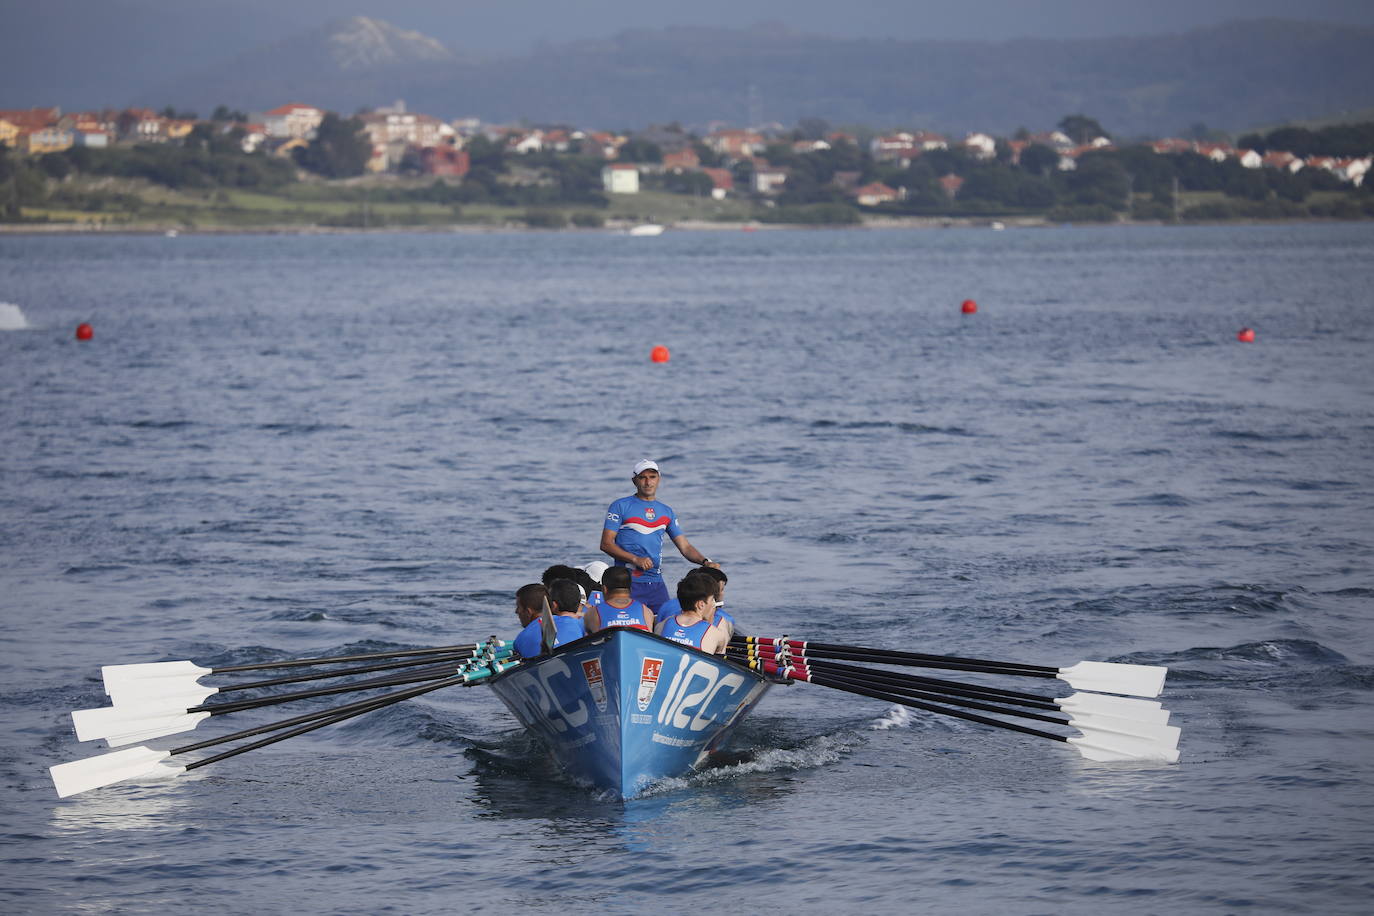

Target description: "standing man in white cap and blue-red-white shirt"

left=600, top=459, right=719, bottom=612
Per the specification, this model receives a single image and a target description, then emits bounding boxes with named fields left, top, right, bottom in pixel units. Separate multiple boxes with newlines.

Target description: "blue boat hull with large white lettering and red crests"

left=491, top=629, right=769, bottom=798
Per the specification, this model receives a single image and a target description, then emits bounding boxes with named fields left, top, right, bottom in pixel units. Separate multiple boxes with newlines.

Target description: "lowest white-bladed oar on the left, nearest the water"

left=48, top=661, right=519, bottom=798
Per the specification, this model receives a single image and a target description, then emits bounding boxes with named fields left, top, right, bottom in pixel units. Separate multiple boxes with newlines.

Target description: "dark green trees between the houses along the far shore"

left=0, top=111, right=1374, bottom=222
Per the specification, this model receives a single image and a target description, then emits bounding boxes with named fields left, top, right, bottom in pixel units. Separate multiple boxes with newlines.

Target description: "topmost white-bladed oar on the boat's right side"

left=738, top=636, right=1169, bottom=696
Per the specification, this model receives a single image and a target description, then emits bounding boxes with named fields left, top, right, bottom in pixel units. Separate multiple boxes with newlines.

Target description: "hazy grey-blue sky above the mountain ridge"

left=0, top=0, right=1374, bottom=107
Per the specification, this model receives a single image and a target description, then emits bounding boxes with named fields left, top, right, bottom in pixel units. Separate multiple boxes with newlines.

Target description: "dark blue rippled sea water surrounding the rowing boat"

left=0, top=222, right=1374, bottom=916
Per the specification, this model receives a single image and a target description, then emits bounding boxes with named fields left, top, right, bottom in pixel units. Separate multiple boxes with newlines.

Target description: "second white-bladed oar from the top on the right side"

left=727, top=645, right=1169, bottom=725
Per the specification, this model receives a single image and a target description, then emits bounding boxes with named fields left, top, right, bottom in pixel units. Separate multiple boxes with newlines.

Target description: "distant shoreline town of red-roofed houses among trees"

left=0, top=102, right=1374, bottom=225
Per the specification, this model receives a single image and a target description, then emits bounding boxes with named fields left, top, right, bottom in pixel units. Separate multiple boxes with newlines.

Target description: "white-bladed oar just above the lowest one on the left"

left=71, top=648, right=510, bottom=747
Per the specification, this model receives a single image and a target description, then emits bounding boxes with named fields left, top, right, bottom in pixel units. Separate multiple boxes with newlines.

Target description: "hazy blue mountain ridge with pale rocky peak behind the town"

left=142, top=16, right=1374, bottom=136
